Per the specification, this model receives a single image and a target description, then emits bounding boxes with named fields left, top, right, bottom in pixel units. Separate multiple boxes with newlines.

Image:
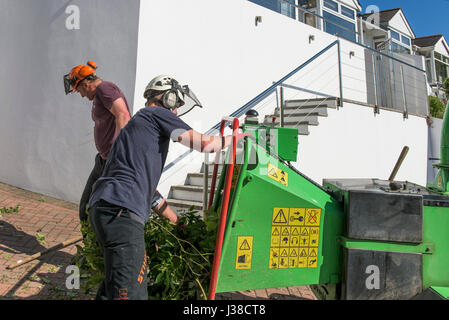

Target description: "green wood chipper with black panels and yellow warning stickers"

left=208, top=110, right=449, bottom=300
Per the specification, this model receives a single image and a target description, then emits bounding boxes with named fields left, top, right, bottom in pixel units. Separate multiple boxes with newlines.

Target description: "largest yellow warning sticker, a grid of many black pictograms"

left=269, top=207, right=321, bottom=269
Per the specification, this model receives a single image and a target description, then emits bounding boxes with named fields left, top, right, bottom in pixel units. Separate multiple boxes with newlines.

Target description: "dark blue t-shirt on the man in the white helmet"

left=89, top=107, right=192, bottom=222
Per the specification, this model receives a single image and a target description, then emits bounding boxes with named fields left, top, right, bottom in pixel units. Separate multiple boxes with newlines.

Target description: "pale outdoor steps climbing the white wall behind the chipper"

left=166, top=98, right=338, bottom=214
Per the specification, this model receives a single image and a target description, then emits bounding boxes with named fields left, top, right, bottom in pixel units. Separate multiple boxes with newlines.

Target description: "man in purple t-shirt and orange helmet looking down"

left=64, top=61, right=177, bottom=222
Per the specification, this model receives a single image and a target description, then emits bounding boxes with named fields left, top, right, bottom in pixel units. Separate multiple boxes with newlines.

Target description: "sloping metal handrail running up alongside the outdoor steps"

left=162, top=40, right=343, bottom=173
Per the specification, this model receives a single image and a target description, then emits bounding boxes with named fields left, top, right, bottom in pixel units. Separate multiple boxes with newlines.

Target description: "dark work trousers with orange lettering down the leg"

left=89, top=200, right=148, bottom=300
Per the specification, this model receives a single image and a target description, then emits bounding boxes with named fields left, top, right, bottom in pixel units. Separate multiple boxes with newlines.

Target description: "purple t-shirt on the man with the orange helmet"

left=92, top=81, right=129, bottom=159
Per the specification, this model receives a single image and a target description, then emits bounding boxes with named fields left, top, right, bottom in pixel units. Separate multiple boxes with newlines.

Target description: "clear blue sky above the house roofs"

left=359, top=0, right=449, bottom=41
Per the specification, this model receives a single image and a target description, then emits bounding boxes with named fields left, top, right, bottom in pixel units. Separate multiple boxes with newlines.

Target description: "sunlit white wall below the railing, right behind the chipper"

left=296, top=103, right=428, bottom=186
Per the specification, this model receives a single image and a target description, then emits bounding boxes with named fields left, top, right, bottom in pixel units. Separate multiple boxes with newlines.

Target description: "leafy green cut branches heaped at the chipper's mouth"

left=78, top=208, right=218, bottom=300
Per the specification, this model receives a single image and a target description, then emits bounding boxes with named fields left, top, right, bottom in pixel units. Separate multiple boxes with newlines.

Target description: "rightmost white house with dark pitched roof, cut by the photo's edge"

left=413, top=34, right=449, bottom=95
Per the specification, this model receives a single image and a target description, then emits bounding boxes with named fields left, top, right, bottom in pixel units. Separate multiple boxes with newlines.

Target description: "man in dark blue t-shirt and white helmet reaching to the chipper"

left=89, top=76, right=248, bottom=300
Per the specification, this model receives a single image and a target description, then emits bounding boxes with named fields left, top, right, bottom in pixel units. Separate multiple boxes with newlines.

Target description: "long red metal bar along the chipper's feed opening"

left=208, top=118, right=239, bottom=300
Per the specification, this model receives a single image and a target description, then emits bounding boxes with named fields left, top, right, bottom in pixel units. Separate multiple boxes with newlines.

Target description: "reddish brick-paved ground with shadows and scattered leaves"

left=0, top=183, right=316, bottom=300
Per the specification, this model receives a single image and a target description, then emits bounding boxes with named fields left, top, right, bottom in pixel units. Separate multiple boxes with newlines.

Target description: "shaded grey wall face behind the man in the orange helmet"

left=0, top=0, right=139, bottom=203
